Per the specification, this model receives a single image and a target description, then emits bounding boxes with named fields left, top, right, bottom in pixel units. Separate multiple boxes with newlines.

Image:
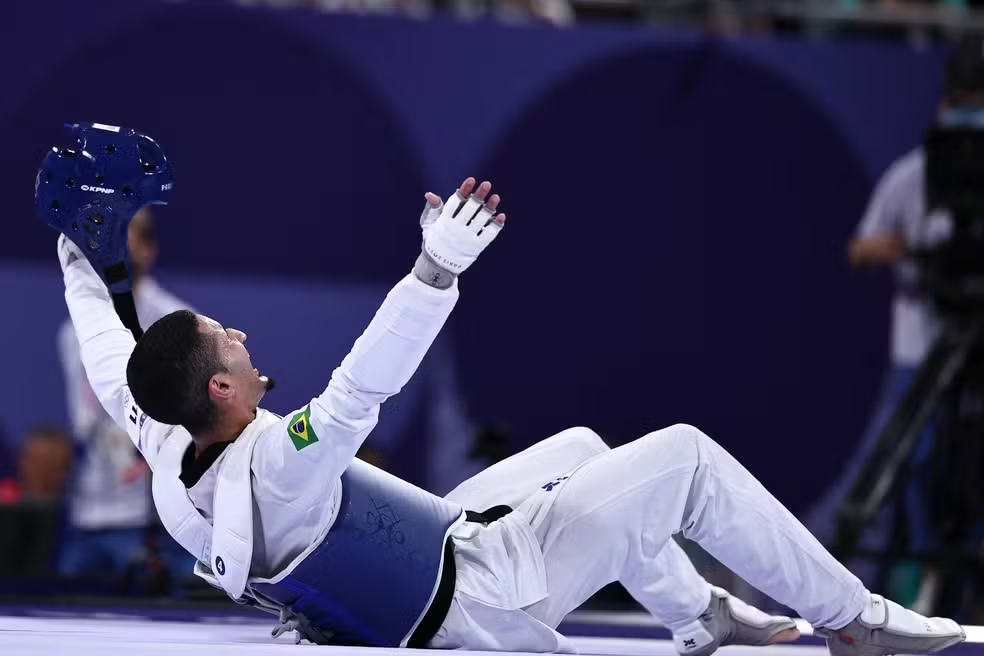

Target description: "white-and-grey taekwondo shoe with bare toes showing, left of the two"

left=673, top=587, right=800, bottom=656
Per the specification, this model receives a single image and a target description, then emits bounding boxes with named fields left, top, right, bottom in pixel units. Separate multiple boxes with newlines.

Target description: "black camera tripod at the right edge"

left=832, top=304, right=984, bottom=617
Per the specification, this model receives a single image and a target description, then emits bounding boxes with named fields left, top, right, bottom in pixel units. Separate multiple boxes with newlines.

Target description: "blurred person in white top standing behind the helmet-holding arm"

left=58, top=208, right=196, bottom=576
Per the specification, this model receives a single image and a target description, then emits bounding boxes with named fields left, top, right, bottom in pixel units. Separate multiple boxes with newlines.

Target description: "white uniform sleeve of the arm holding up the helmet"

left=63, top=250, right=174, bottom=468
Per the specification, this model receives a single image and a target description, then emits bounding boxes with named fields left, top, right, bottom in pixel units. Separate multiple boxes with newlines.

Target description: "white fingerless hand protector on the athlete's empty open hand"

left=420, top=192, right=502, bottom=276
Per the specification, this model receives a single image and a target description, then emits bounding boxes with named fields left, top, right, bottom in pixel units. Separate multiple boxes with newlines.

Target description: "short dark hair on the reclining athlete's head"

left=126, top=310, right=225, bottom=435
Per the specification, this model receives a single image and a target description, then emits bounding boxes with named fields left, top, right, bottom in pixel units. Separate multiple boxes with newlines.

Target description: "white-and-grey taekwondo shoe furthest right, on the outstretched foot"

left=814, top=594, right=967, bottom=656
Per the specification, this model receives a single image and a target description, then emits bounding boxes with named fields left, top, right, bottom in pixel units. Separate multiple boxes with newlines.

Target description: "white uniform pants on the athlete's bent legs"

left=431, top=425, right=868, bottom=652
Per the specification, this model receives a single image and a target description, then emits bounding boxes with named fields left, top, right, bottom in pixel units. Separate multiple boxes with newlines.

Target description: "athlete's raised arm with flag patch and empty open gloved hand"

left=253, top=178, right=505, bottom=490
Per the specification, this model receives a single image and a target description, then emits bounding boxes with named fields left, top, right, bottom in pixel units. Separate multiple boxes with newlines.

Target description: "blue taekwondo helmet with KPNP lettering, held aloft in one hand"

left=34, top=123, right=174, bottom=294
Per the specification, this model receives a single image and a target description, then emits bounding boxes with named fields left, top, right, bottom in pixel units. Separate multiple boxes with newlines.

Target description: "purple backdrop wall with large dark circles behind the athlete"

left=0, top=0, right=952, bottom=510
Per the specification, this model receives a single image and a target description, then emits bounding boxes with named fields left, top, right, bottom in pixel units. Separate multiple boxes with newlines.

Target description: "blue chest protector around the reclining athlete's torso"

left=250, top=460, right=465, bottom=647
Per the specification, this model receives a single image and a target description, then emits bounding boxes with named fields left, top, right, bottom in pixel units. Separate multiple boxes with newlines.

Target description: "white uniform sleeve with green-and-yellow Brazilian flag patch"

left=253, top=275, right=458, bottom=498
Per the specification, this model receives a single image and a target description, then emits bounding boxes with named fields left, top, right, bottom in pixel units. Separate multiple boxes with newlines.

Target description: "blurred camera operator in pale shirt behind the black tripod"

left=807, top=35, right=984, bottom=612
